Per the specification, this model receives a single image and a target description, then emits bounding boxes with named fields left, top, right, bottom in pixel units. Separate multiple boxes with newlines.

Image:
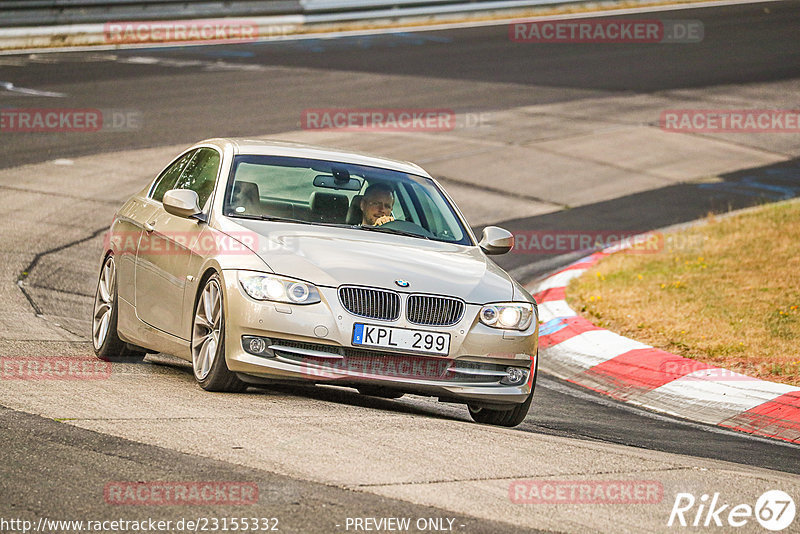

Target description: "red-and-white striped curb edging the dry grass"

left=526, top=251, right=800, bottom=443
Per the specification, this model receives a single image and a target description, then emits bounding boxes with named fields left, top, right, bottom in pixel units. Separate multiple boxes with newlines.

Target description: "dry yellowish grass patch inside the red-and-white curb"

left=567, top=201, right=800, bottom=385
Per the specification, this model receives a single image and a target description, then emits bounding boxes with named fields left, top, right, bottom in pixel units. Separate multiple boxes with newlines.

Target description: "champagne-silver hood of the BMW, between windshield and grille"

left=225, top=220, right=514, bottom=304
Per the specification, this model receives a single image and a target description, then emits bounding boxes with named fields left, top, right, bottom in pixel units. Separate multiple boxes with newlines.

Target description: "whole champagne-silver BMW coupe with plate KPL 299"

left=92, top=139, right=538, bottom=426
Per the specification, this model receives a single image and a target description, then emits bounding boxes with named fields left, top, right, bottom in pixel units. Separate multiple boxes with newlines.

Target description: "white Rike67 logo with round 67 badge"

left=667, top=490, right=796, bottom=532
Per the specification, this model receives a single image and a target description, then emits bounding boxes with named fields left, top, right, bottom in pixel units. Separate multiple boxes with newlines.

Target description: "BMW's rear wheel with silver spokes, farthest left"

left=92, top=255, right=147, bottom=363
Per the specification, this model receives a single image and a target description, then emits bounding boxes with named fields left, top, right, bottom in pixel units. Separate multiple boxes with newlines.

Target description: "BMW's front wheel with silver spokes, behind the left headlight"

left=192, top=274, right=247, bottom=393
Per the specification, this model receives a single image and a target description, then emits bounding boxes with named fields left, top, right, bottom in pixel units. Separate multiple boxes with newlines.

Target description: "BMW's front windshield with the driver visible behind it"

left=223, top=156, right=472, bottom=245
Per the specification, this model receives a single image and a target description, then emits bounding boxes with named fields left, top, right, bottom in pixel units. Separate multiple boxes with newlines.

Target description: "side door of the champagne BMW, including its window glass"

left=136, top=147, right=221, bottom=339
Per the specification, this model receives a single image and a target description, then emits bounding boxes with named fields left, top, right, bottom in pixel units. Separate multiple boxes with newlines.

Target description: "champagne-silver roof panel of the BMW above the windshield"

left=197, top=138, right=430, bottom=177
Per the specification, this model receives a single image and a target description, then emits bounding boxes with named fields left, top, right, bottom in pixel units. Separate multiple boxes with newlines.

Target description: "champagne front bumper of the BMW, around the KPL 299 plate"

left=222, top=271, right=538, bottom=406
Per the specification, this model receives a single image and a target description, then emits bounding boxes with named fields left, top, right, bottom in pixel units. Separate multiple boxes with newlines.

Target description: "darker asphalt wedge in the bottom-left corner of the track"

left=0, top=407, right=536, bottom=534
